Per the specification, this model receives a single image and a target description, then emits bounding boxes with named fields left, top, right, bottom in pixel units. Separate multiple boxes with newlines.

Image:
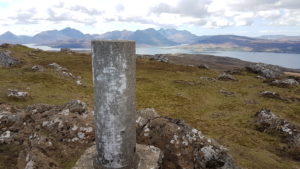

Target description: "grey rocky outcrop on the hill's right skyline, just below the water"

left=246, top=63, right=283, bottom=79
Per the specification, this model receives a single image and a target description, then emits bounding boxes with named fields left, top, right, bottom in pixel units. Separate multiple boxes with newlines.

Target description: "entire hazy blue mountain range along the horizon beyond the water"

left=0, top=28, right=300, bottom=53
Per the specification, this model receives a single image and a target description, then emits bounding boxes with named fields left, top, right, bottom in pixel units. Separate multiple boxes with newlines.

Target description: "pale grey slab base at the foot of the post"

left=72, top=144, right=163, bottom=169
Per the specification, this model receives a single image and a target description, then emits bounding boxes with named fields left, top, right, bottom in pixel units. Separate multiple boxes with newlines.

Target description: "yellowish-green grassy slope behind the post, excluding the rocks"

left=0, top=46, right=300, bottom=169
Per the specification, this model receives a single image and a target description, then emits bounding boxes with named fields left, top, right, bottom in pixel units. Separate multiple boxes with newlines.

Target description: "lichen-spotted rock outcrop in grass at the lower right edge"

left=255, top=109, right=300, bottom=160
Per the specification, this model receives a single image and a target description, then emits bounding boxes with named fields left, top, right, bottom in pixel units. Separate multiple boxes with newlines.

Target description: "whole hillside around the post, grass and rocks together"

left=0, top=45, right=300, bottom=169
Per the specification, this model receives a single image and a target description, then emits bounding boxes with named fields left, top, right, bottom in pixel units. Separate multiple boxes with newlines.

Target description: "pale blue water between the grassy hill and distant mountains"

left=25, top=44, right=300, bottom=69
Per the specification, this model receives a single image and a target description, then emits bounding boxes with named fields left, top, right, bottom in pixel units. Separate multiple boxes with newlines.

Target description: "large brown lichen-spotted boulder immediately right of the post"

left=136, top=109, right=238, bottom=169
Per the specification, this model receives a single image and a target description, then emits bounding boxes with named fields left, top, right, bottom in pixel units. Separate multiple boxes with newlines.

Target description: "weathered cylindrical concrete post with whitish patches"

left=92, top=40, right=136, bottom=169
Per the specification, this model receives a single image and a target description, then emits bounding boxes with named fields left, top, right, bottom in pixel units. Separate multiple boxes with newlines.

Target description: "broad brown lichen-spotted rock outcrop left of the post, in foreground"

left=0, top=101, right=94, bottom=169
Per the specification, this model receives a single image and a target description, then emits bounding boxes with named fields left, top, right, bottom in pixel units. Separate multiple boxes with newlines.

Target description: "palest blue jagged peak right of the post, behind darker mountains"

left=158, top=29, right=199, bottom=44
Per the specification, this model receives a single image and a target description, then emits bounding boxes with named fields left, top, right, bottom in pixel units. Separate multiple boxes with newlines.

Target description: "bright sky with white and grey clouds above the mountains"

left=0, top=0, right=300, bottom=37
